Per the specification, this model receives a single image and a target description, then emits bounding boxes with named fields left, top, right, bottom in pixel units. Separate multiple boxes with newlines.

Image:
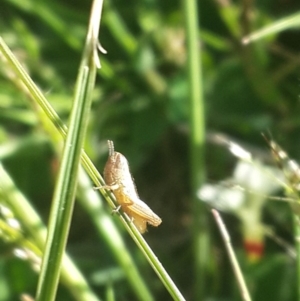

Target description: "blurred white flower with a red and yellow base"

left=197, top=157, right=284, bottom=261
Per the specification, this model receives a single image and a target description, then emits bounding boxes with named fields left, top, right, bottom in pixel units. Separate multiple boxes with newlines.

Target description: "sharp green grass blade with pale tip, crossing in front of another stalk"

left=36, top=0, right=103, bottom=301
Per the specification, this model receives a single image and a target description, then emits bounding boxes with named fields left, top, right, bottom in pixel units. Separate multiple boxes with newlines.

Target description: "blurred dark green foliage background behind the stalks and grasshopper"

left=0, top=0, right=300, bottom=301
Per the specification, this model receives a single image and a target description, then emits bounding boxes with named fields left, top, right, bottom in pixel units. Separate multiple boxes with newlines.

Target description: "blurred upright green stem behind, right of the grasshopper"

left=183, top=0, right=209, bottom=300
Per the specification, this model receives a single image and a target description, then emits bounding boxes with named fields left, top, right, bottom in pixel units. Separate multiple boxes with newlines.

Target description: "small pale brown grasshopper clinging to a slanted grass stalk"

left=102, top=140, right=162, bottom=233
